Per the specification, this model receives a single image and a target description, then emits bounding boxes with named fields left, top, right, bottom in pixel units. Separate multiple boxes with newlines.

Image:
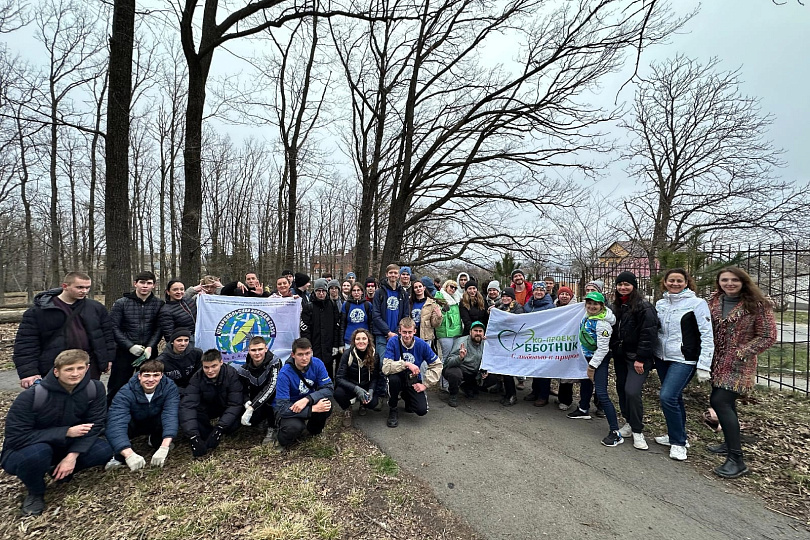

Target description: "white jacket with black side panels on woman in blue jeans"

left=655, top=289, right=714, bottom=371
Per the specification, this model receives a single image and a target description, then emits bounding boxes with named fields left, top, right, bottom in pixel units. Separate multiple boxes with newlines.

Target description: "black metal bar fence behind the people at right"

left=548, top=244, right=810, bottom=395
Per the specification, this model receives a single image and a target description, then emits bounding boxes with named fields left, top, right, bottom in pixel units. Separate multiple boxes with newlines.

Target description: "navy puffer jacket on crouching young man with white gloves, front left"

left=106, top=374, right=180, bottom=454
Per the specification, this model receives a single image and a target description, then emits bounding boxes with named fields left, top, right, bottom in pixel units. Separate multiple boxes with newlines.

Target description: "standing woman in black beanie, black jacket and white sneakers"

left=612, top=271, right=658, bottom=450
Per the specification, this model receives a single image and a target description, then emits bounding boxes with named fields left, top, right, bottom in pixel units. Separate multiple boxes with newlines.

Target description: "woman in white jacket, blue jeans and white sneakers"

left=655, top=268, right=714, bottom=461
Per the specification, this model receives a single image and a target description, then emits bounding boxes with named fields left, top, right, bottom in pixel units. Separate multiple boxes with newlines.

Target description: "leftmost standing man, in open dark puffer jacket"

left=14, top=272, right=115, bottom=388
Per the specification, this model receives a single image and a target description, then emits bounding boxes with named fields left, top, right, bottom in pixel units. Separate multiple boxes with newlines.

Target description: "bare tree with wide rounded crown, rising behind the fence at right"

left=623, top=55, right=810, bottom=271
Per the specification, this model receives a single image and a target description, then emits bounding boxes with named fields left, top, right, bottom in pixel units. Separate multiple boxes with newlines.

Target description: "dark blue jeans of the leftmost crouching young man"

left=3, top=436, right=112, bottom=495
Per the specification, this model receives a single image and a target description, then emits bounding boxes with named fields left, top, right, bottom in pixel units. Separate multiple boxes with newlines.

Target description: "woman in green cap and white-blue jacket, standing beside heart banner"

left=572, top=292, right=624, bottom=446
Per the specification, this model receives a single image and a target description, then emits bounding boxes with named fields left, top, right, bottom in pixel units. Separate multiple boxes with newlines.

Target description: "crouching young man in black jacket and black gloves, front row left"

left=180, top=349, right=245, bottom=457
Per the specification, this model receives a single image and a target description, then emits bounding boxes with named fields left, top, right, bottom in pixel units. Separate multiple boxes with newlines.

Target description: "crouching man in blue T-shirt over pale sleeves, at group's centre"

left=383, top=317, right=442, bottom=428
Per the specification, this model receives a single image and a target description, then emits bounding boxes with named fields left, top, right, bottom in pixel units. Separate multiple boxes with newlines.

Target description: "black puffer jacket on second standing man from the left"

left=110, top=291, right=165, bottom=350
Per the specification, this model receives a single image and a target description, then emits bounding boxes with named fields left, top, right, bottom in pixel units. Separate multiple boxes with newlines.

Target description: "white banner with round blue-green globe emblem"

left=194, top=294, right=301, bottom=364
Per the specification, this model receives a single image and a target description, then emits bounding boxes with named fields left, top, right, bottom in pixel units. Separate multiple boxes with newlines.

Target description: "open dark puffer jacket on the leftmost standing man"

left=13, top=289, right=115, bottom=379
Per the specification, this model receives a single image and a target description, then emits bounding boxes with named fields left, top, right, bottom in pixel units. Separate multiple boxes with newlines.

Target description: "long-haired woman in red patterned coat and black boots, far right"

left=697, top=266, right=776, bottom=478
